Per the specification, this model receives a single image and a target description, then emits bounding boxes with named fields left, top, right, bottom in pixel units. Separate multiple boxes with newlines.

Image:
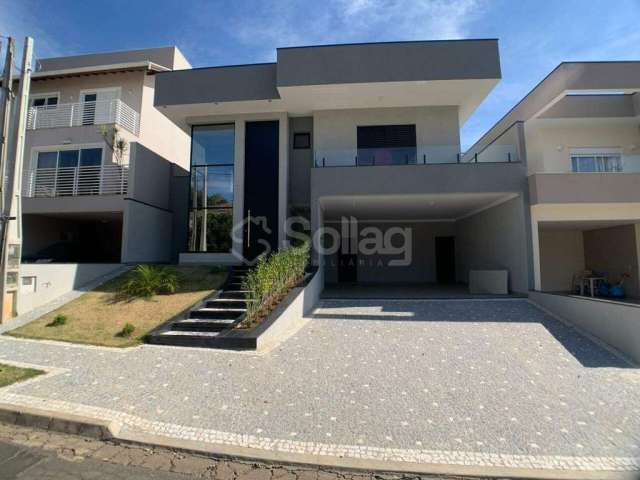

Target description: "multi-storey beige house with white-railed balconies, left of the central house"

left=22, top=47, right=191, bottom=263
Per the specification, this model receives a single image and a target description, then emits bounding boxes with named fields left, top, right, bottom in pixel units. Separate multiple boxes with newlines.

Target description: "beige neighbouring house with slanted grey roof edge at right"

left=467, top=62, right=640, bottom=298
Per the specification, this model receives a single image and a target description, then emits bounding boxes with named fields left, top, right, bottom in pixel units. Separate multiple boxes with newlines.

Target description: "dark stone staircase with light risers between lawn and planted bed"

left=146, top=266, right=250, bottom=348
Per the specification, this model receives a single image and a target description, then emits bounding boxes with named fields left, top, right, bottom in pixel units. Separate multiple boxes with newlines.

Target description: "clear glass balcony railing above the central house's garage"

left=314, top=144, right=518, bottom=168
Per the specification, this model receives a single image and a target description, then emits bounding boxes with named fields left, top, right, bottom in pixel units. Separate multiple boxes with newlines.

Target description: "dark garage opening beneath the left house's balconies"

left=22, top=212, right=122, bottom=263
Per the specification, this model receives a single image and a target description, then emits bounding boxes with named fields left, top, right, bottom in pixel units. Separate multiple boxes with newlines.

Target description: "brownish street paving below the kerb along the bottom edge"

left=0, top=423, right=436, bottom=480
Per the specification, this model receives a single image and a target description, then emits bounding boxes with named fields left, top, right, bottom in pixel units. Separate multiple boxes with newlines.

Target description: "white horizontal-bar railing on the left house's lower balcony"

left=23, top=165, right=129, bottom=197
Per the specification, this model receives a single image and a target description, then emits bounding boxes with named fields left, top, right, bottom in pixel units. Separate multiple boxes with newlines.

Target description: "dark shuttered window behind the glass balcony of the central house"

left=357, top=125, right=417, bottom=166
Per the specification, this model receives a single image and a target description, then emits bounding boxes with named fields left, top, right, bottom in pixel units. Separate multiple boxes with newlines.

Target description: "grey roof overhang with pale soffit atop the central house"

left=155, top=40, right=501, bottom=126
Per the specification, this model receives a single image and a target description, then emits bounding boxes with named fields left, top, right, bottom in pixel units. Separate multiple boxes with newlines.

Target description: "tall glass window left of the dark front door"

left=189, top=124, right=235, bottom=252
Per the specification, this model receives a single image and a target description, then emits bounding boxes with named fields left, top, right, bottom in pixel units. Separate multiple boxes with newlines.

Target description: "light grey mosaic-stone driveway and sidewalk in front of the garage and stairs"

left=0, top=300, right=640, bottom=470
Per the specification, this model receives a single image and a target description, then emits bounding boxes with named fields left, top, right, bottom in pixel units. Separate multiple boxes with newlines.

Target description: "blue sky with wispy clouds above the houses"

left=0, top=0, right=640, bottom=148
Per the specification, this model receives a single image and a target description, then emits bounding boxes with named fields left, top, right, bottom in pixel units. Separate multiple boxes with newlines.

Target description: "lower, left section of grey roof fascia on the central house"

left=154, top=63, right=280, bottom=106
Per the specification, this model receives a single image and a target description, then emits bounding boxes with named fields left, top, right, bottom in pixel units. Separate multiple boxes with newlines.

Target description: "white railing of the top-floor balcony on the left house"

left=27, top=99, right=140, bottom=135
